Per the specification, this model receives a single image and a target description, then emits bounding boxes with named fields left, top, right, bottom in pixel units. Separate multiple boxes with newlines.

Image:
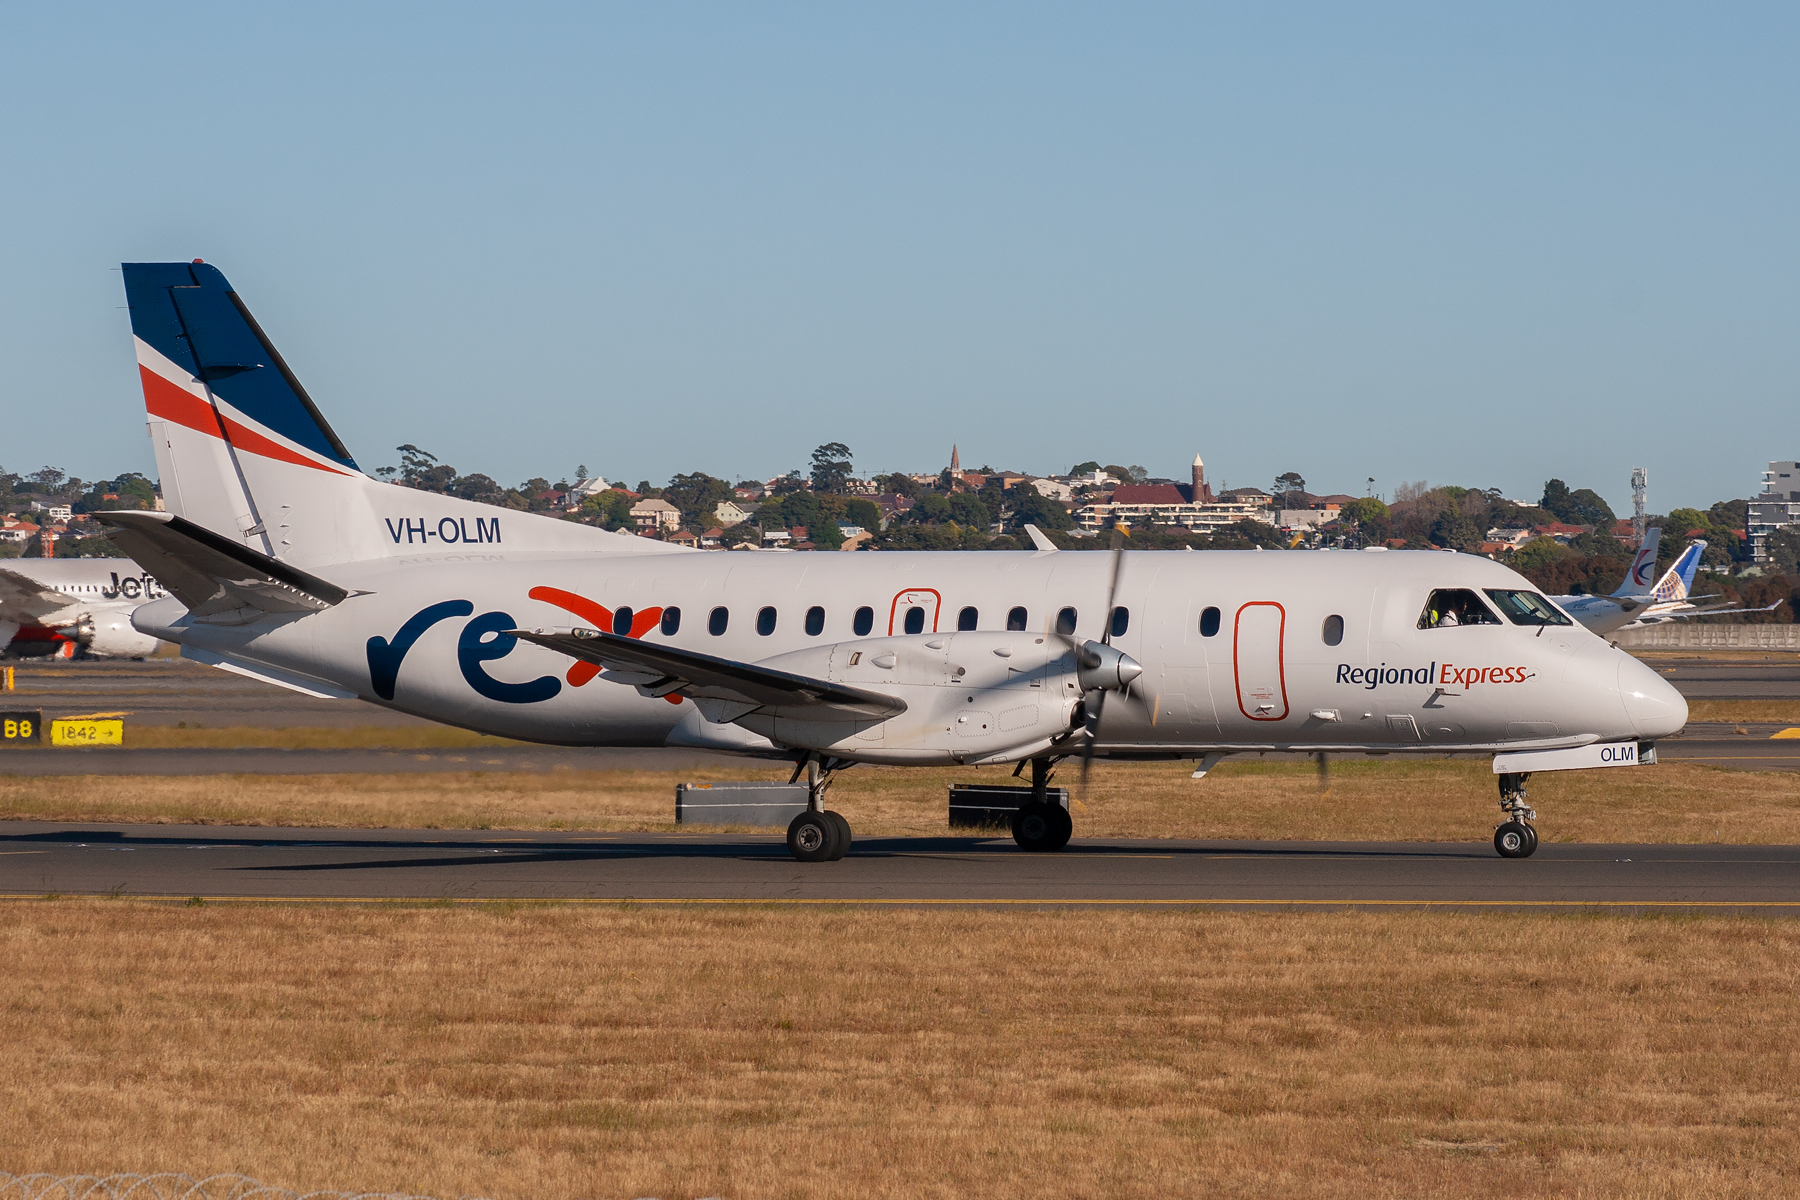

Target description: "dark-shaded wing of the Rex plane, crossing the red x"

left=508, top=628, right=905, bottom=723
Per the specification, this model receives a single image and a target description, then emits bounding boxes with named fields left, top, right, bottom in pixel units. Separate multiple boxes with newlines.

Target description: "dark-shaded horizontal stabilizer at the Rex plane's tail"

left=95, top=513, right=349, bottom=621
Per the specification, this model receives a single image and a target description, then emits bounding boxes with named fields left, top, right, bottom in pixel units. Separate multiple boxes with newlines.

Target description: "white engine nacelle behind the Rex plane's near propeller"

left=741, top=630, right=1082, bottom=765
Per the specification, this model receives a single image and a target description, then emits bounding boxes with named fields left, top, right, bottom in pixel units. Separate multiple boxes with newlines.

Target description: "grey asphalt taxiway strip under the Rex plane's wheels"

left=0, top=822, right=1800, bottom=916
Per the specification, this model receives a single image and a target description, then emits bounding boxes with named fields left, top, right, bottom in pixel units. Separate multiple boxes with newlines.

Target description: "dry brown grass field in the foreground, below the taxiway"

left=0, top=900, right=1800, bottom=1200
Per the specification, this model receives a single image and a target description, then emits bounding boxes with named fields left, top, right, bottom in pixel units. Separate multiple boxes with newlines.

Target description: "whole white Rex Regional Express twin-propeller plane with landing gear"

left=101, top=259, right=1687, bottom=862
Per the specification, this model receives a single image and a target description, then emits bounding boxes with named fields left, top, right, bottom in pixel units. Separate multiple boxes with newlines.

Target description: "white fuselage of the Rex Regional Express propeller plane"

left=137, top=547, right=1687, bottom=763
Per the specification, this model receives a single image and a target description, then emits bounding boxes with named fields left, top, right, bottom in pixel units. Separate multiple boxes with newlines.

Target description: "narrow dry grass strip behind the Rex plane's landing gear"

left=0, top=752, right=1800, bottom=844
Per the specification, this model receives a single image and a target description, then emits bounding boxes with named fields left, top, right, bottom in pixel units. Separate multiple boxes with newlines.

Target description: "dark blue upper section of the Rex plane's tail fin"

left=124, top=263, right=356, bottom=470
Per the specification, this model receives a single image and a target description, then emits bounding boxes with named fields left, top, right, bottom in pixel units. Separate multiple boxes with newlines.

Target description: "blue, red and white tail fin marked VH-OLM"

left=124, top=259, right=675, bottom=565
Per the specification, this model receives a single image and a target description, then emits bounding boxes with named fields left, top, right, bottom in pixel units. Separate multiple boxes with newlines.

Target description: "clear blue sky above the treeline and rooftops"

left=0, top=4, right=1800, bottom=511
